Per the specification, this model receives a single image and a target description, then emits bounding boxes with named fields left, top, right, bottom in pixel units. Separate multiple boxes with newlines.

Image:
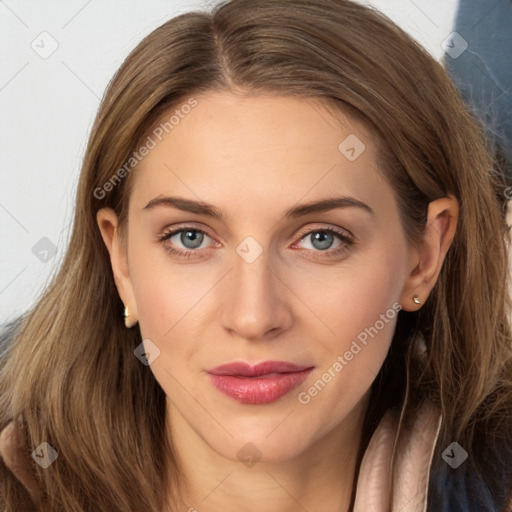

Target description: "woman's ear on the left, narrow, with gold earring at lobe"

left=96, top=208, right=138, bottom=327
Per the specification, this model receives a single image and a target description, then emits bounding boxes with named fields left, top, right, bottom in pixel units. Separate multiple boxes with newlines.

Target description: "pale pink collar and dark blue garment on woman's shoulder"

left=354, top=403, right=512, bottom=512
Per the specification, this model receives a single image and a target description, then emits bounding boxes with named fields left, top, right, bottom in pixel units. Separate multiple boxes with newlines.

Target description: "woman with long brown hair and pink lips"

left=0, top=0, right=512, bottom=512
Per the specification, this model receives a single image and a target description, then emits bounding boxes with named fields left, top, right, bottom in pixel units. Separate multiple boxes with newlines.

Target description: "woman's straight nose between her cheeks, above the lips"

left=221, top=246, right=293, bottom=341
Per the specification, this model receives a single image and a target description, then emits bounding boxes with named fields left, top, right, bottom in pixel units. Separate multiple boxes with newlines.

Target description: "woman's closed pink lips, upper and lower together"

left=208, top=361, right=313, bottom=404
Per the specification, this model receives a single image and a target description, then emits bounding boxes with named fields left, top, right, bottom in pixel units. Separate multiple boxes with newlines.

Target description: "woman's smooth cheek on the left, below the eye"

left=130, top=244, right=219, bottom=382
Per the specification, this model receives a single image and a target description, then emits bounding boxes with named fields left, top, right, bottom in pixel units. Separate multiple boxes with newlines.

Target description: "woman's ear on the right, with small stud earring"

left=400, top=195, right=459, bottom=311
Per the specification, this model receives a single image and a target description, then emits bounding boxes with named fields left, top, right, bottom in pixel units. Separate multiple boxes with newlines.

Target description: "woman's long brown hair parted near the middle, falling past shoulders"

left=0, top=0, right=512, bottom=512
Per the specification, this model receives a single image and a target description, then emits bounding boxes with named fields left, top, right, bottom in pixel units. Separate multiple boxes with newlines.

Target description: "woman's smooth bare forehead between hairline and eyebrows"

left=132, top=92, right=389, bottom=217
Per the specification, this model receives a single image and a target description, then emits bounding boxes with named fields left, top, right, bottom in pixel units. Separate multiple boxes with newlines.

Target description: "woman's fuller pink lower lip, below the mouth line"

left=210, top=368, right=313, bottom=404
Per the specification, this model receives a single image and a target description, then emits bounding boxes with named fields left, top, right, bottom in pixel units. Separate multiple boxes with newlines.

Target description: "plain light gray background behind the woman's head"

left=0, top=0, right=457, bottom=323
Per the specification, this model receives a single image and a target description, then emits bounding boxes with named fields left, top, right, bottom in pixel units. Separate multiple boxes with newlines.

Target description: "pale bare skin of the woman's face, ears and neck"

left=0, top=91, right=458, bottom=512
